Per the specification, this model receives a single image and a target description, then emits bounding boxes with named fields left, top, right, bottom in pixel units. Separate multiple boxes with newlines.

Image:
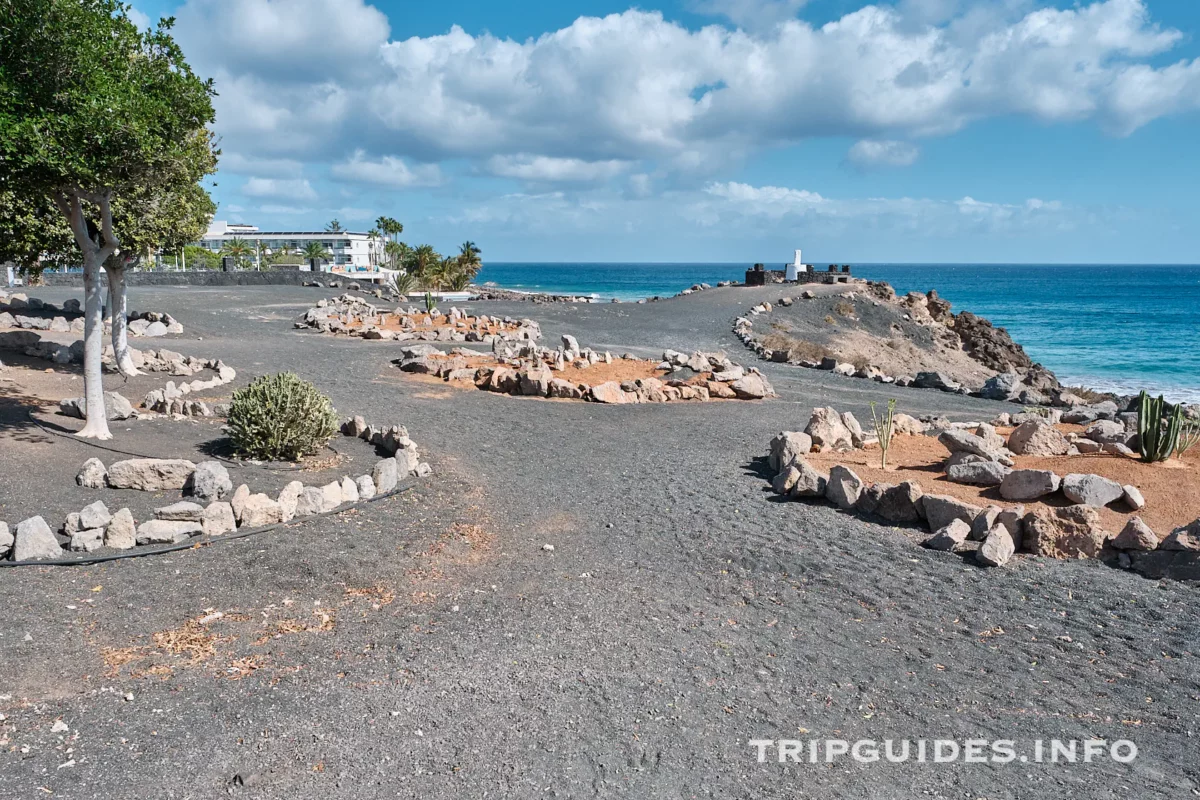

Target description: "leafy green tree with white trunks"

left=0, top=0, right=218, bottom=439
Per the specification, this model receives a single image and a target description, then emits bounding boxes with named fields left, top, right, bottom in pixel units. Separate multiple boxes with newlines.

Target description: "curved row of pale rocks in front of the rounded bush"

left=0, top=416, right=433, bottom=566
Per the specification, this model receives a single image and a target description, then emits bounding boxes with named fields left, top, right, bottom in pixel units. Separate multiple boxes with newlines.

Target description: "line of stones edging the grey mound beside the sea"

left=732, top=289, right=1087, bottom=408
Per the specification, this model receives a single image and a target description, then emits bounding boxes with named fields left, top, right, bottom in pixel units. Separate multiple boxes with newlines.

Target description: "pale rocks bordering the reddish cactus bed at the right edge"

left=768, top=408, right=1200, bottom=581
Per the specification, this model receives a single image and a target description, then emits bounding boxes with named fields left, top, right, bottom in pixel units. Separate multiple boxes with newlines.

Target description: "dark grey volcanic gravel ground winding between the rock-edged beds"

left=0, top=288, right=1200, bottom=800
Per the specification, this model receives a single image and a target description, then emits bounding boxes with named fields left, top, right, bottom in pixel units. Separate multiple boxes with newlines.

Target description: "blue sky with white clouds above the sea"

left=136, top=0, right=1200, bottom=263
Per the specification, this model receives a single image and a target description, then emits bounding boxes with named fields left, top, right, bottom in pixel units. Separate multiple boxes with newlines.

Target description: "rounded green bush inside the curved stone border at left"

left=228, top=372, right=337, bottom=461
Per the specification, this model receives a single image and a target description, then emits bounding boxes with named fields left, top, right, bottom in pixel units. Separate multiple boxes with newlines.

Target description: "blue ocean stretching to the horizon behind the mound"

left=478, top=263, right=1200, bottom=403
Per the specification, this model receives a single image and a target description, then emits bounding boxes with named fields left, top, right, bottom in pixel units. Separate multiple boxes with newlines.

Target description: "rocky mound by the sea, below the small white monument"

left=733, top=282, right=1086, bottom=408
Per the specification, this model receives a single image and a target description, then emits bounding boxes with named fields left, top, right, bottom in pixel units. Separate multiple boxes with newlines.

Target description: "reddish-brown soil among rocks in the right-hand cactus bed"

left=809, top=425, right=1200, bottom=537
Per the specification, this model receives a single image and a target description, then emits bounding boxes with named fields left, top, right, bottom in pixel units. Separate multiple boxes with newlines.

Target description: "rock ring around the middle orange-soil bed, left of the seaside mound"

left=394, top=335, right=775, bottom=405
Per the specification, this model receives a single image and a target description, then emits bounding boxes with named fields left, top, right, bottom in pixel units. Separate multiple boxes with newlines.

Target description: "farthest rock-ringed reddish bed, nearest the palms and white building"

left=295, top=294, right=541, bottom=344
